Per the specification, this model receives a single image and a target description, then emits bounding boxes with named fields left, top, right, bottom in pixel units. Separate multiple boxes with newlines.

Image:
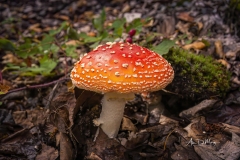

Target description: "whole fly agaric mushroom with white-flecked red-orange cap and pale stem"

left=71, top=42, right=174, bottom=138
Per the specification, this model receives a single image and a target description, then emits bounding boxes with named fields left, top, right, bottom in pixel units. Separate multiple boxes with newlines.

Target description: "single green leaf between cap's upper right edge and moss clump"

left=152, top=39, right=175, bottom=55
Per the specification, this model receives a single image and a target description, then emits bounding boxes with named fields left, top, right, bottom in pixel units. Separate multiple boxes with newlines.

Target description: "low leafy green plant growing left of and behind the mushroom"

left=0, top=10, right=148, bottom=76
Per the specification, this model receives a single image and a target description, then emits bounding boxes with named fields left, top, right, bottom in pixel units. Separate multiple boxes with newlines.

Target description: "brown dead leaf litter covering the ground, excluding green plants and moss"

left=0, top=0, right=240, bottom=160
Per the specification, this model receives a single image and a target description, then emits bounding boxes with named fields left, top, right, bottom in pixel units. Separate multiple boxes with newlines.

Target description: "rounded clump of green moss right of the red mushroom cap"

left=164, top=48, right=230, bottom=100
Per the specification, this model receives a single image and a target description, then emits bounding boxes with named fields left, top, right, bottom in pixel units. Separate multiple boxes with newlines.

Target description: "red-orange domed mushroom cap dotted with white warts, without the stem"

left=71, top=42, right=174, bottom=93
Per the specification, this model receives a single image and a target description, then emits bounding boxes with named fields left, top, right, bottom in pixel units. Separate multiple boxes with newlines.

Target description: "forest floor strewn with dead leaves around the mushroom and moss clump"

left=0, top=0, right=240, bottom=160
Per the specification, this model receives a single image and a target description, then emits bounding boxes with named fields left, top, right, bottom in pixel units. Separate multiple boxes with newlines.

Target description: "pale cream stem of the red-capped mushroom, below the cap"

left=93, top=92, right=135, bottom=138
